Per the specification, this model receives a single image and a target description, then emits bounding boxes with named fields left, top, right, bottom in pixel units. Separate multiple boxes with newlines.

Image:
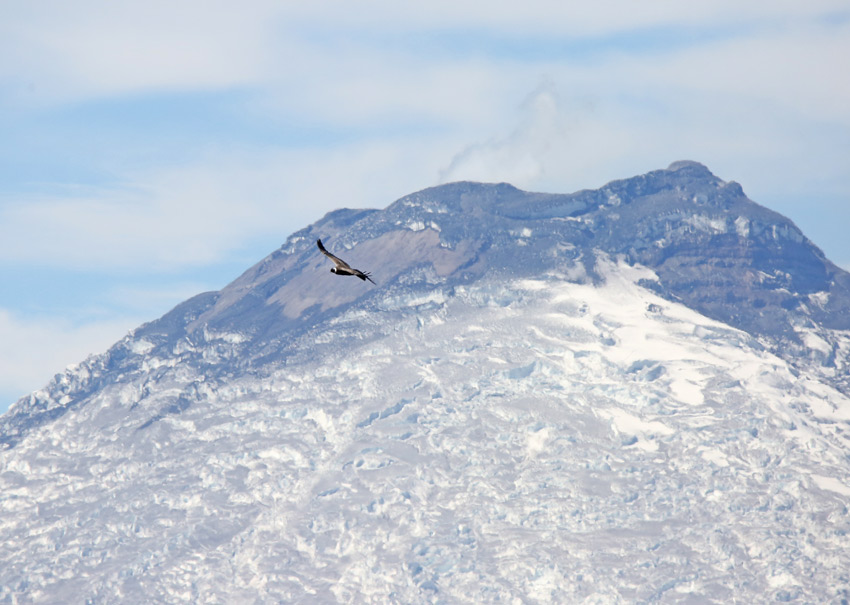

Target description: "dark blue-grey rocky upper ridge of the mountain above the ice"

left=0, top=161, right=850, bottom=446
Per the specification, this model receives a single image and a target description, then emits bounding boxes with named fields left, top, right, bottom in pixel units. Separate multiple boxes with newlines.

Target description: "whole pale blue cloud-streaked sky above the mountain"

left=0, top=0, right=850, bottom=411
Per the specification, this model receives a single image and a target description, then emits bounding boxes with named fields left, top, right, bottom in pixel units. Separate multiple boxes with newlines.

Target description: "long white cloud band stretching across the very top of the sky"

left=0, top=0, right=848, bottom=115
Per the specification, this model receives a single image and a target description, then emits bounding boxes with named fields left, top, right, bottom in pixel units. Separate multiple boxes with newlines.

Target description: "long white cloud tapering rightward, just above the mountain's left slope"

left=0, top=142, right=448, bottom=273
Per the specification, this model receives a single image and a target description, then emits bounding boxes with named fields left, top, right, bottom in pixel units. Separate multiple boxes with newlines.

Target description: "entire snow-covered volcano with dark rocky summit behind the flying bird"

left=0, top=162, right=850, bottom=603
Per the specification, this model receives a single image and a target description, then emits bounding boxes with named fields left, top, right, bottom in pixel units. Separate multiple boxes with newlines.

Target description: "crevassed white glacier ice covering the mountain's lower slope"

left=0, top=263, right=850, bottom=603
